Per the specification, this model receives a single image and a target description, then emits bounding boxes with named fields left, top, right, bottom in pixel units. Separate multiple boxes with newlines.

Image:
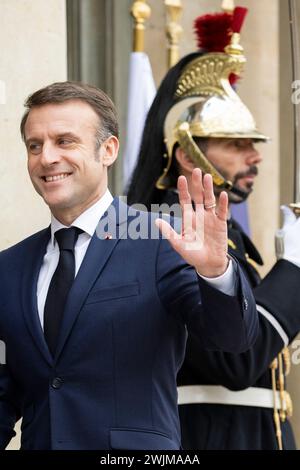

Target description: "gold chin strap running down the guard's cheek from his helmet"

left=177, top=122, right=249, bottom=203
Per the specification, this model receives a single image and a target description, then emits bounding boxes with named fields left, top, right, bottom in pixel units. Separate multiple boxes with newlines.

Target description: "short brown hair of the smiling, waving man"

left=20, top=81, right=119, bottom=146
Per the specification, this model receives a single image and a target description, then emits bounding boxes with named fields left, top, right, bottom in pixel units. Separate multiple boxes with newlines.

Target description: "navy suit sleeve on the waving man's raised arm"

left=156, top=240, right=258, bottom=353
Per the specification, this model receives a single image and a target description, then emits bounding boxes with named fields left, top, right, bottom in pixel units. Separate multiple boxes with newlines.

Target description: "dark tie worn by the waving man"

left=44, top=227, right=82, bottom=356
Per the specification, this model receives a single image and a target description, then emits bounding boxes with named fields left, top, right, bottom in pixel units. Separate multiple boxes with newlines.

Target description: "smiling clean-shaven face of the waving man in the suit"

left=25, top=99, right=118, bottom=224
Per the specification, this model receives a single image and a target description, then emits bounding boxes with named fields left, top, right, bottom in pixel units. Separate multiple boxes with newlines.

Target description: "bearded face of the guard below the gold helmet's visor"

left=205, top=139, right=262, bottom=194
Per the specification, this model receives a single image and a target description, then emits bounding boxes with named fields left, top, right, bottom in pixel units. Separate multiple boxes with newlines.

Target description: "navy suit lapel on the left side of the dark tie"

left=22, top=228, right=53, bottom=365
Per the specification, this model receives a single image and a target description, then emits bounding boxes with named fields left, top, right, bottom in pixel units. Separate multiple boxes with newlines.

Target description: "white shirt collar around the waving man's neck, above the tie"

left=51, top=189, right=113, bottom=247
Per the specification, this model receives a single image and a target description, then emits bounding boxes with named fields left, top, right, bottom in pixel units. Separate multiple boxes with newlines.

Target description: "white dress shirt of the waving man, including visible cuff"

left=37, top=189, right=236, bottom=328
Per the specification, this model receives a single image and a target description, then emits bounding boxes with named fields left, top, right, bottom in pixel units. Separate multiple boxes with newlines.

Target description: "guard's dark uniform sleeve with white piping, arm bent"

left=179, top=260, right=300, bottom=390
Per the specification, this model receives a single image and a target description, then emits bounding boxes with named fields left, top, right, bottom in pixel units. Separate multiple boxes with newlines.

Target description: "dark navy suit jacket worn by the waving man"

left=0, top=199, right=257, bottom=449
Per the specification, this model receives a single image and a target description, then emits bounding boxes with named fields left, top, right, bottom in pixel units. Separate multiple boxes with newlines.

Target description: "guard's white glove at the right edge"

left=275, top=206, right=300, bottom=268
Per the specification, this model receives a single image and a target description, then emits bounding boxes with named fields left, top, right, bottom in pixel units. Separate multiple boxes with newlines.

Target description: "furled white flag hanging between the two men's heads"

left=123, top=52, right=156, bottom=189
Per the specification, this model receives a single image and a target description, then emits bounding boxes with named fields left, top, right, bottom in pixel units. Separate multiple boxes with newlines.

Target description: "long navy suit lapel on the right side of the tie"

left=55, top=198, right=128, bottom=360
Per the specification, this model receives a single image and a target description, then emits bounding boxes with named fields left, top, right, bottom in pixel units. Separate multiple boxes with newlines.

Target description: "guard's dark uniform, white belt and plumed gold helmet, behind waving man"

left=128, top=5, right=300, bottom=450
